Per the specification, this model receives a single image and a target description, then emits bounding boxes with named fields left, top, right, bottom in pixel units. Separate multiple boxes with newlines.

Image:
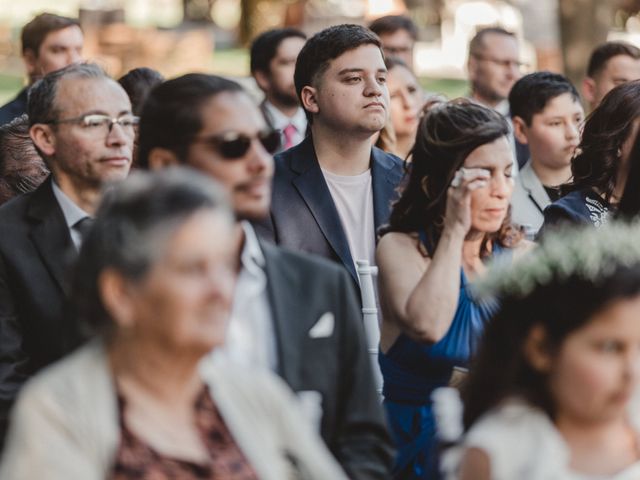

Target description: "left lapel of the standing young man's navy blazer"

left=291, top=137, right=358, bottom=280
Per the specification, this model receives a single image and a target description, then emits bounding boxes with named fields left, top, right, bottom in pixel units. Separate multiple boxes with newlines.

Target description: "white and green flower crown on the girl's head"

left=473, top=221, right=640, bottom=298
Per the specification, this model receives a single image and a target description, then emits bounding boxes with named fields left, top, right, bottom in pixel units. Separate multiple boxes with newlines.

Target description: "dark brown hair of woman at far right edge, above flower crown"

left=562, top=80, right=640, bottom=202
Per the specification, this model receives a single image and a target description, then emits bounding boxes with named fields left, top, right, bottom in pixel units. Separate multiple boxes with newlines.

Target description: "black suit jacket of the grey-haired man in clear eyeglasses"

left=0, top=178, right=77, bottom=446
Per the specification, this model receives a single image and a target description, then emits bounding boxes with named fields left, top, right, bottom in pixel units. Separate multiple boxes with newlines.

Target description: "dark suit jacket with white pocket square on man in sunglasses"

left=261, top=242, right=393, bottom=479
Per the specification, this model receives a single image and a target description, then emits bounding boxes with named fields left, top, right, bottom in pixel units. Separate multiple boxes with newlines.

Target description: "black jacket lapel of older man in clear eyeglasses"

left=27, top=177, right=73, bottom=292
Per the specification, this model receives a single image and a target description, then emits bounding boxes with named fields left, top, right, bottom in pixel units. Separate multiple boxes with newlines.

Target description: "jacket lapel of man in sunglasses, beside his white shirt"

left=260, top=241, right=306, bottom=384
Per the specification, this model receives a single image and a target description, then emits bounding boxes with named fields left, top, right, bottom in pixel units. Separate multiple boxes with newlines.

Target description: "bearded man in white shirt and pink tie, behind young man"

left=251, top=28, right=307, bottom=150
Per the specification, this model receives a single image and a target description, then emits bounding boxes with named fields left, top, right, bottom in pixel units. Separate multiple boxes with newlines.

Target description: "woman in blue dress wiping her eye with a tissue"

left=376, top=99, right=524, bottom=480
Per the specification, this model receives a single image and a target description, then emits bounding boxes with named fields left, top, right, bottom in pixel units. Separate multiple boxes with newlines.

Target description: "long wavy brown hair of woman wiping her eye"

left=380, top=98, right=522, bottom=256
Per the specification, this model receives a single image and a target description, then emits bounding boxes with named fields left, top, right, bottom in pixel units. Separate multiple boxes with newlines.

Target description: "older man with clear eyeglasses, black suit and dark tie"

left=0, top=64, right=137, bottom=448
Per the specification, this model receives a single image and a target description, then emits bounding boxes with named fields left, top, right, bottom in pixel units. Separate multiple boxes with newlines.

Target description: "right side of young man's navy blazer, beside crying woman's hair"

left=371, top=147, right=402, bottom=232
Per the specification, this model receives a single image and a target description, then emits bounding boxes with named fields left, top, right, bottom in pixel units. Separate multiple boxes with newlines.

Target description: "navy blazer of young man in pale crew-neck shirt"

left=257, top=137, right=403, bottom=283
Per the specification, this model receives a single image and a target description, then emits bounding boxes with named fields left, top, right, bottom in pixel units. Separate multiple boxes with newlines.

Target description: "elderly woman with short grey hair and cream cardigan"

left=0, top=170, right=346, bottom=480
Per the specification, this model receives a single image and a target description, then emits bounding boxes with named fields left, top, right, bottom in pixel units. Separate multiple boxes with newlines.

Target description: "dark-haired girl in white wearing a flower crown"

left=448, top=224, right=640, bottom=480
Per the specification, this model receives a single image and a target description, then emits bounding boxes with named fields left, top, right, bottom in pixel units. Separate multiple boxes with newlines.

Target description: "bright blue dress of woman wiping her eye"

left=378, top=235, right=504, bottom=480
